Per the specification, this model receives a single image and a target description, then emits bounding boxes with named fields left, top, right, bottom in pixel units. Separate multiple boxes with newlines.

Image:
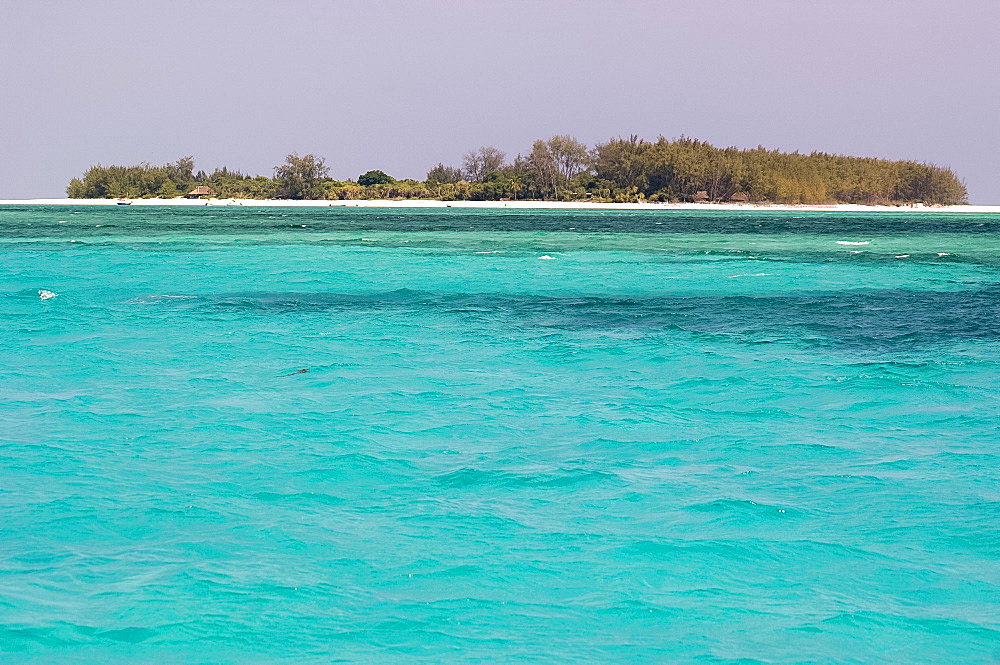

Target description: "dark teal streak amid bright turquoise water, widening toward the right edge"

left=121, top=286, right=1000, bottom=347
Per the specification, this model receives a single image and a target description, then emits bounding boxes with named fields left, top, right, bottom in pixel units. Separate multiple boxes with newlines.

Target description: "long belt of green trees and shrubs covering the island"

left=66, top=135, right=968, bottom=205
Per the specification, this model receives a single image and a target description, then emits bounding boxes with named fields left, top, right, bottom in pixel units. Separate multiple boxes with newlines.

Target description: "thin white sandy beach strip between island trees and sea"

left=0, top=198, right=1000, bottom=214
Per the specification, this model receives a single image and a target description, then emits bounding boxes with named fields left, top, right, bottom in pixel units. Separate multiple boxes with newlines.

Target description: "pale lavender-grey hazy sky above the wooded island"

left=0, top=0, right=1000, bottom=204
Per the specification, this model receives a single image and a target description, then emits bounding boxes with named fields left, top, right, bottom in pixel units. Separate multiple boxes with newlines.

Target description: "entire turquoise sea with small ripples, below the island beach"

left=0, top=206, right=1000, bottom=664
